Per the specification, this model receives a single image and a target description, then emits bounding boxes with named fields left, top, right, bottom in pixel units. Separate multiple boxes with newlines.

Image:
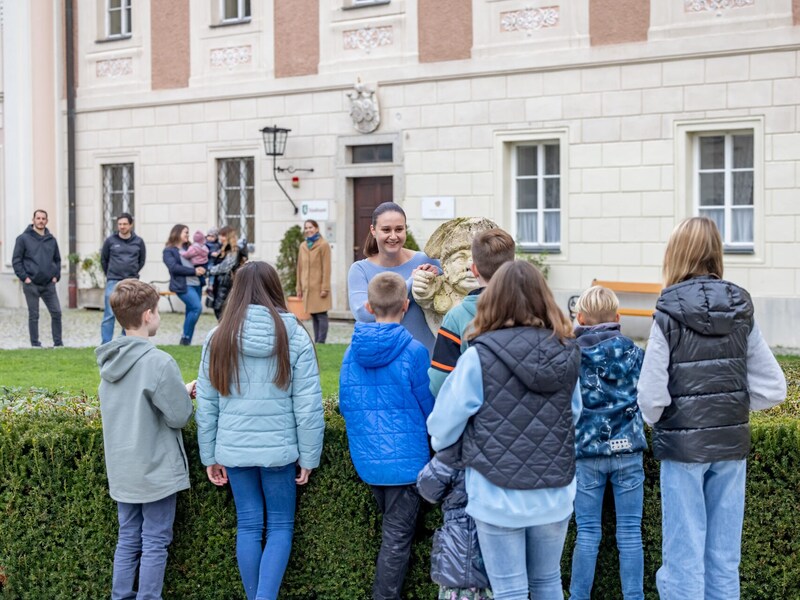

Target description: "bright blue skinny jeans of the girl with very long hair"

left=227, top=463, right=297, bottom=600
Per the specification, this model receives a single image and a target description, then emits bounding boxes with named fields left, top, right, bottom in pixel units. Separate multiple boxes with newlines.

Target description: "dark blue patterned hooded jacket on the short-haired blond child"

left=575, top=323, right=647, bottom=458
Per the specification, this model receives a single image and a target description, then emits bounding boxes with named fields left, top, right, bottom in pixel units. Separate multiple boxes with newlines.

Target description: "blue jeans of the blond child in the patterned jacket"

left=569, top=452, right=644, bottom=600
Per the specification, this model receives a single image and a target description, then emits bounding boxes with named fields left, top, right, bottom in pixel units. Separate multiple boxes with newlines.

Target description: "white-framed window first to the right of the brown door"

left=511, top=142, right=561, bottom=250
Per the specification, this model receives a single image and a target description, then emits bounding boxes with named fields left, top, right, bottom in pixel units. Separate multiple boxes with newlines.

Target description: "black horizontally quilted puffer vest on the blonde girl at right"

left=653, top=276, right=753, bottom=463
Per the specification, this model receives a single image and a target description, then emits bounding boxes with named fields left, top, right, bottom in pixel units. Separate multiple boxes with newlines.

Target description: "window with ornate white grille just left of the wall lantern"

left=217, top=157, right=256, bottom=243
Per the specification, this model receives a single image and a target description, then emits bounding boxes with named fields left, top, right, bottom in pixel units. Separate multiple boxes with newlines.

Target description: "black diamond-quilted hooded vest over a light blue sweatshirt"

left=462, top=327, right=581, bottom=490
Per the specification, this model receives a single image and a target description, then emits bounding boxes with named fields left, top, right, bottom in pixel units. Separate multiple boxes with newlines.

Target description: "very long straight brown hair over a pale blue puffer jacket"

left=208, top=261, right=292, bottom=396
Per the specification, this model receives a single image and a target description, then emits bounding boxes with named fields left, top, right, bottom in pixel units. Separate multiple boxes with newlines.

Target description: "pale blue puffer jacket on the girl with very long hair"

left=195, top=305, right=325, bottom=469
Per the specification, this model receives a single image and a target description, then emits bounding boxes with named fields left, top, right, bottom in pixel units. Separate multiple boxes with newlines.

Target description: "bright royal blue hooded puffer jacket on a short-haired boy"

left=339, top=323, right=433, bottom=485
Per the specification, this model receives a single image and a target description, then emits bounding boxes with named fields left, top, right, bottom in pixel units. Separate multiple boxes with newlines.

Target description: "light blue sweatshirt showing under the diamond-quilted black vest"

left=428, top=347, right=582, bottom=527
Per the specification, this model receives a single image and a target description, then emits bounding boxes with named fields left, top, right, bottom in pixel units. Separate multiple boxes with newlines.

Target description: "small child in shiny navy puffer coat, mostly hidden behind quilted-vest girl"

left=417, top=445, right=494, bottom=600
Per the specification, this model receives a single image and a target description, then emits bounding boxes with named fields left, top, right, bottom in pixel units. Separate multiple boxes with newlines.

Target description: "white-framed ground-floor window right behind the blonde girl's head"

left=693, top=130, right=754, bottom=251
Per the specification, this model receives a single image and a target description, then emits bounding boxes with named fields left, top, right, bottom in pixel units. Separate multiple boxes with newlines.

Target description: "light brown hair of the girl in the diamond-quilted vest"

left=469, top=260, right=574, bottom=340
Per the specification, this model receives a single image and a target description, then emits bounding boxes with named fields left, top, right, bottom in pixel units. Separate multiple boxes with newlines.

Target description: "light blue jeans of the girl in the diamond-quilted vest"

left=475, top=518, right=569, bottom=600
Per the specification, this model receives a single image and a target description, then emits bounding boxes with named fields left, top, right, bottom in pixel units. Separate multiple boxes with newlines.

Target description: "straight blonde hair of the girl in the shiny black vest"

left=662, top=217, right=722, bottom=287
